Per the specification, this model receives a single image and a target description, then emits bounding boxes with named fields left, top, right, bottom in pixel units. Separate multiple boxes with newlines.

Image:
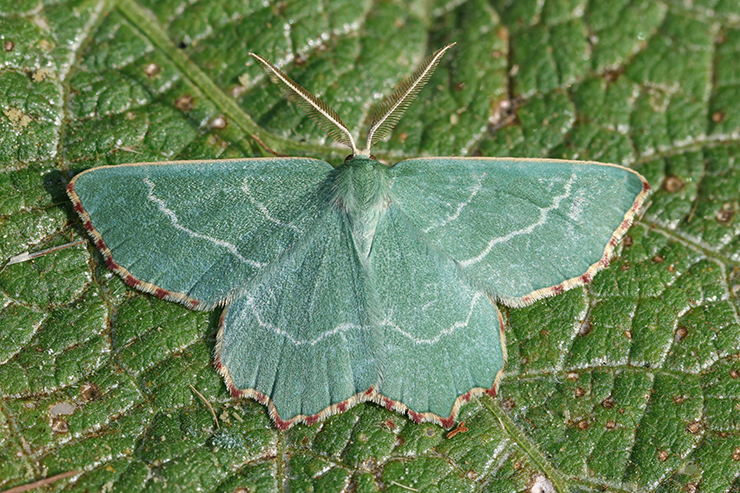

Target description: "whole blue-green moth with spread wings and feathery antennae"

left=68, top=45, right=649, bottom=429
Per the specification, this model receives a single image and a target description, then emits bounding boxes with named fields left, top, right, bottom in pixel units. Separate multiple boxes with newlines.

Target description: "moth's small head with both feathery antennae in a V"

left=250, top=43, right=455, bottom=162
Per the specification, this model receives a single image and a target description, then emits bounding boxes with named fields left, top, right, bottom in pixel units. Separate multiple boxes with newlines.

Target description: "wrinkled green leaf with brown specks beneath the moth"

left=0, top=0, right=740, bottom=493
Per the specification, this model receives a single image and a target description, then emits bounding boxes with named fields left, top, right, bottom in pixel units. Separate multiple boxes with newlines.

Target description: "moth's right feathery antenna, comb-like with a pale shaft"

left=366, top=43, right=455, bottom=152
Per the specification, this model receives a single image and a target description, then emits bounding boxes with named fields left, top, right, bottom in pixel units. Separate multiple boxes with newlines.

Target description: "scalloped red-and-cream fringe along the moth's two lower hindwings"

left=214, top=296, right=508, bottom=431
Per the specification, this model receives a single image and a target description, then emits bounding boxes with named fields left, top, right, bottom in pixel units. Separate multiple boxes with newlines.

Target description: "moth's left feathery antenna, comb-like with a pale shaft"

left=250, top=53, right=362, bottom=155
